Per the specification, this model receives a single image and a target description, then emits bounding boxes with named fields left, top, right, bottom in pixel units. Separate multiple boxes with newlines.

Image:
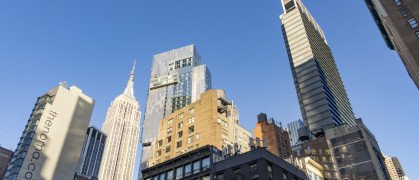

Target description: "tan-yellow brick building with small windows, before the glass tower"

left=150, top=89, right=251, bottom=166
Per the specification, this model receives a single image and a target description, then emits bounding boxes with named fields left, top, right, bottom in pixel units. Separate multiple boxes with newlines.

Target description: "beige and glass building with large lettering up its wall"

left=4, top=83, right=95, bottom=180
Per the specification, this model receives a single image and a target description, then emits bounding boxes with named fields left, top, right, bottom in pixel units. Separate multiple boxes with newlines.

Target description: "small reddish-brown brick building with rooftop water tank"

left=253, top=113, right=291, bottom=159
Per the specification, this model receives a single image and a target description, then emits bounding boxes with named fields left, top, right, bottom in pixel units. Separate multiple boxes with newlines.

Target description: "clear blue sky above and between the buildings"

left=0, top=0, right=419, bottom=179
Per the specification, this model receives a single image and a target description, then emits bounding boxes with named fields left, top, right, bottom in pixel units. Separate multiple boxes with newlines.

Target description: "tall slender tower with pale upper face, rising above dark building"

left=280, top=0, right=356, bottom=135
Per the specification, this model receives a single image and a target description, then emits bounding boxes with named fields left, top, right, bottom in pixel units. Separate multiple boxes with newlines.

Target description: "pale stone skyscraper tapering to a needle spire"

left=99, top=63, right=141, bottom=180
